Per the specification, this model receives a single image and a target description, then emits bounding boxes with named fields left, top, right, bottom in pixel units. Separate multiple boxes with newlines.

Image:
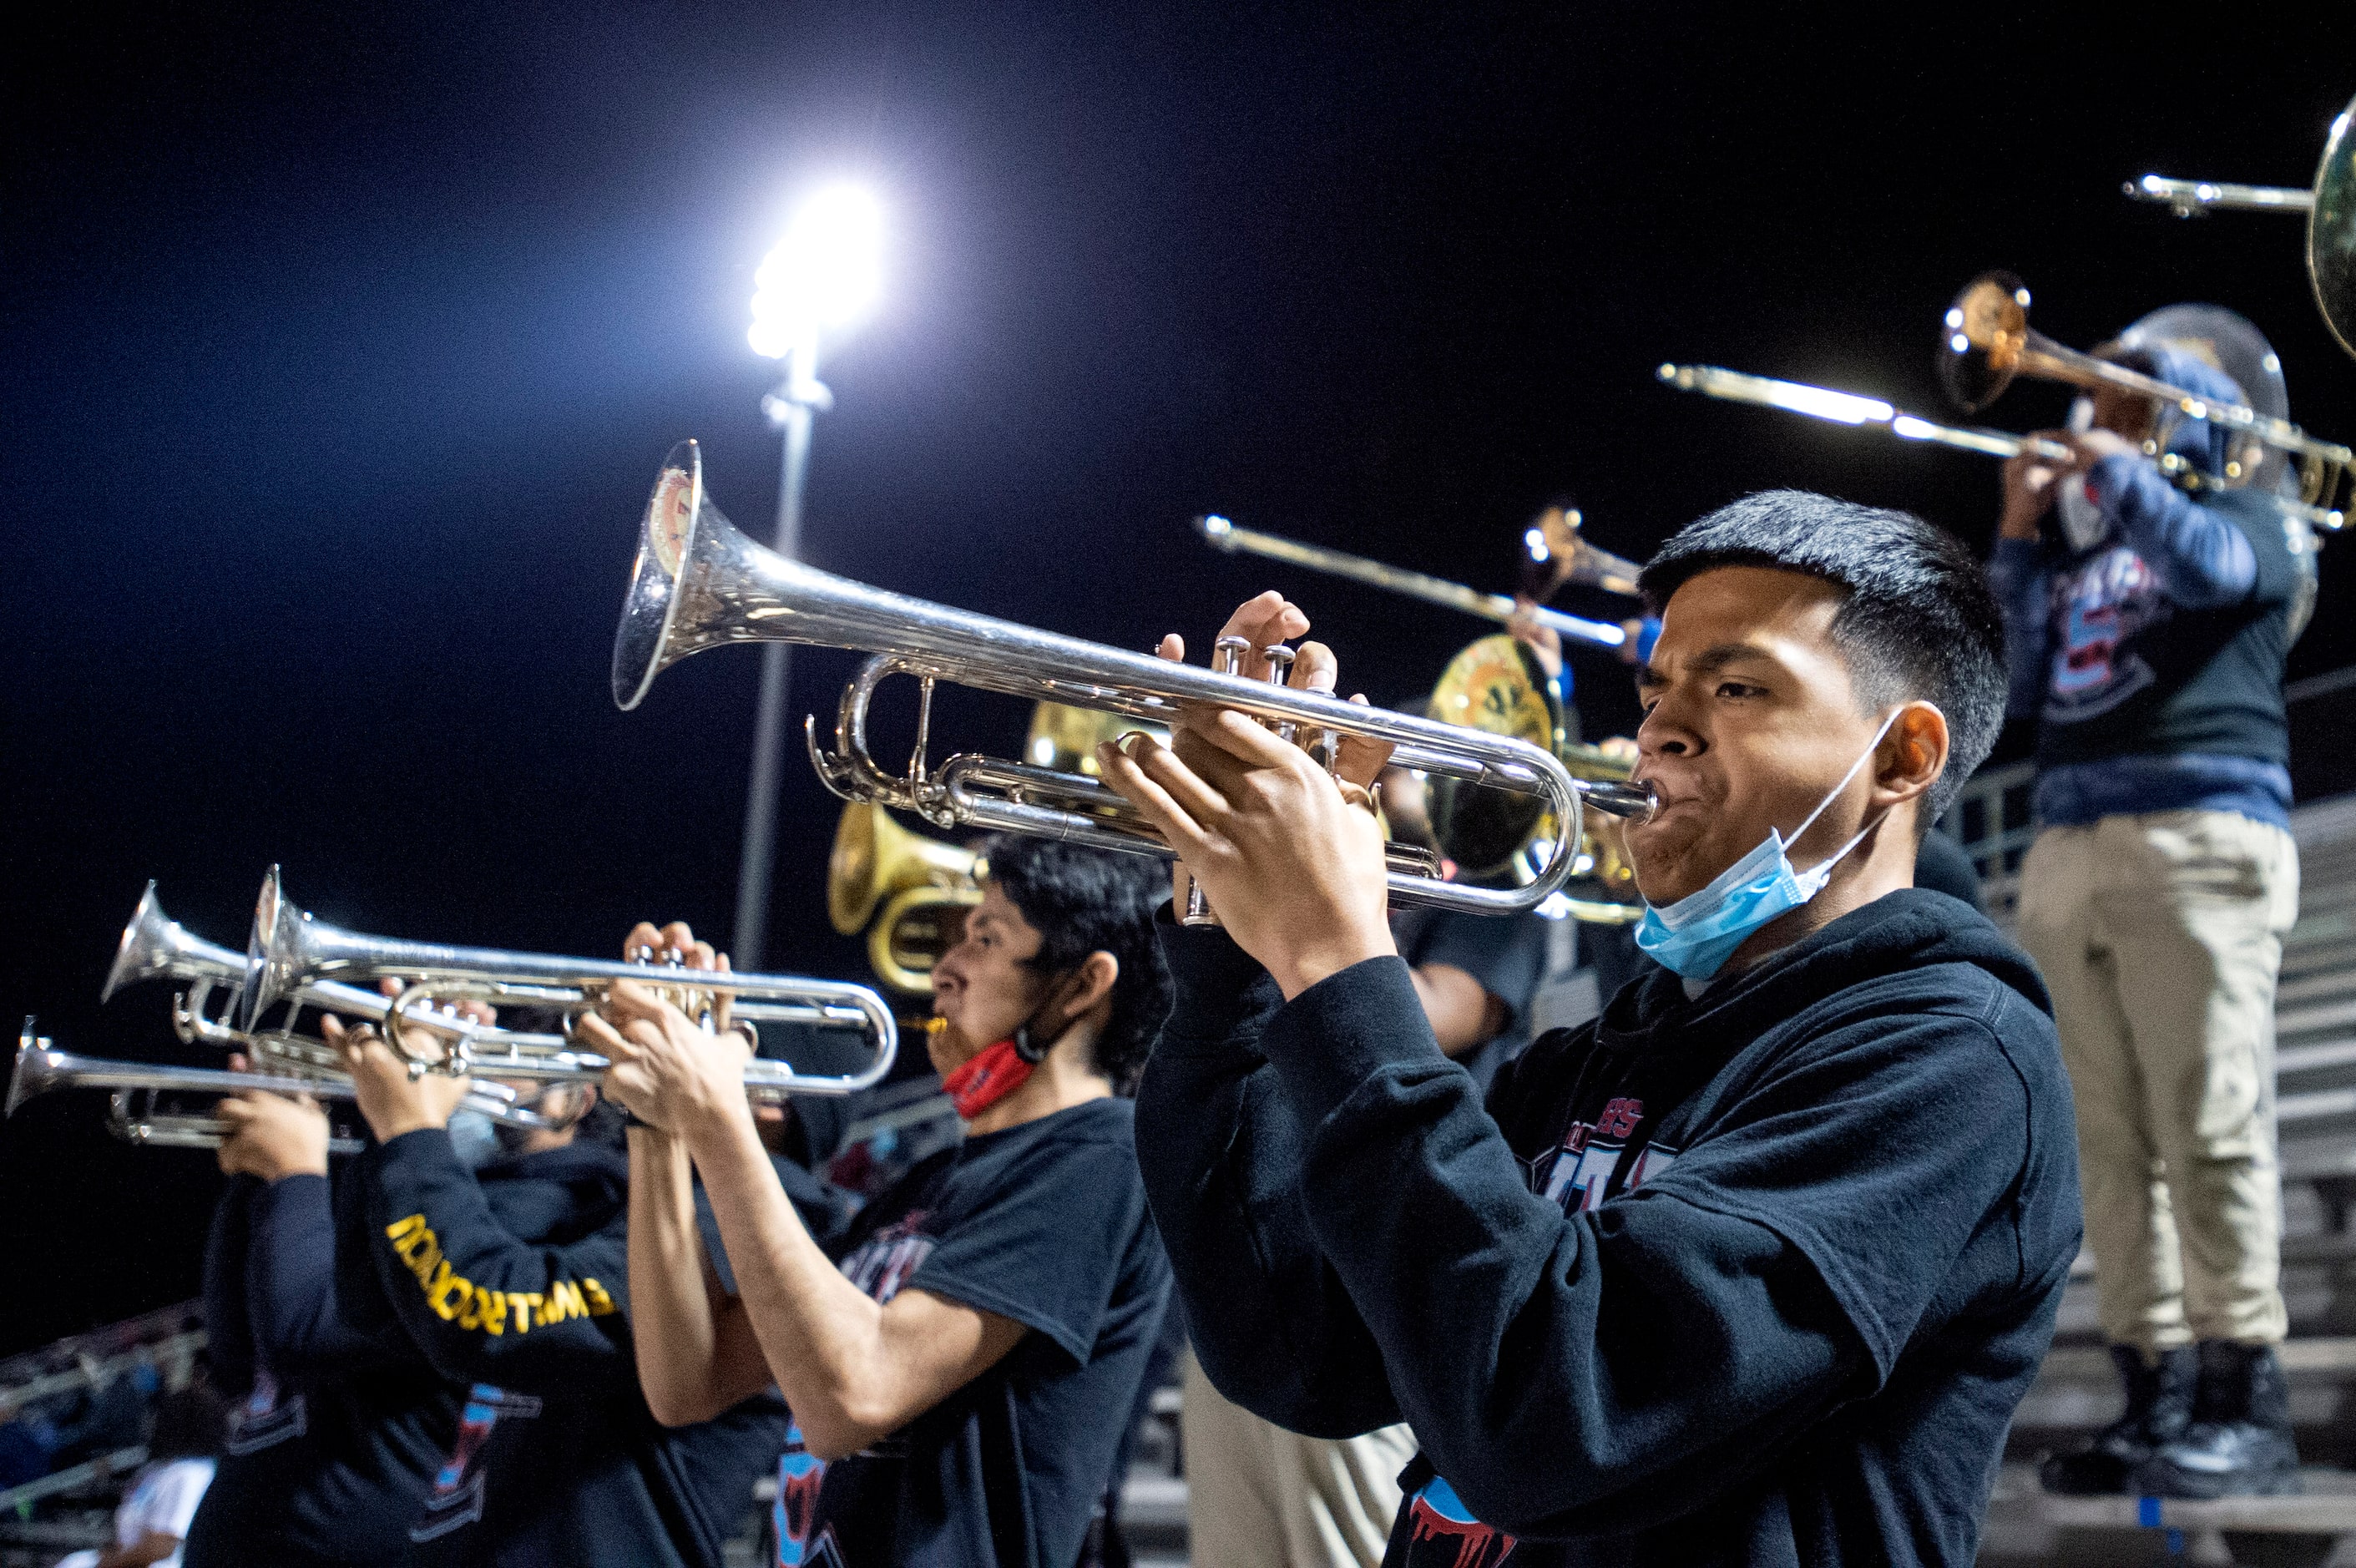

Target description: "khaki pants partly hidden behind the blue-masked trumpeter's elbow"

left=1178, top=1351, right=1416, bottom=1568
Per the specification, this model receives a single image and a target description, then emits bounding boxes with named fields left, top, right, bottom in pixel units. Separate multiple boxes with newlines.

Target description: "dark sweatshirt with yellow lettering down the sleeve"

left=356, top=1127, right=785, bottom=1568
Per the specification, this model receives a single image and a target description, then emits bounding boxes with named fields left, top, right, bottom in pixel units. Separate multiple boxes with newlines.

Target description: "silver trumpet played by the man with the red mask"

left=240, top=865, right=900, bottom=1099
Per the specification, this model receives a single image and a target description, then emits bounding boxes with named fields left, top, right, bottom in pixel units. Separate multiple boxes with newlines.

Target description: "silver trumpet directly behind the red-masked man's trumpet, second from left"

left=99, top=882, right=573, bottom=1126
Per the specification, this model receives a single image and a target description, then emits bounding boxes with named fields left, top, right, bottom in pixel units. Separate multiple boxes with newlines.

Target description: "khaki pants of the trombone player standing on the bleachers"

left=2019, top=811, right=2299, bottom=1356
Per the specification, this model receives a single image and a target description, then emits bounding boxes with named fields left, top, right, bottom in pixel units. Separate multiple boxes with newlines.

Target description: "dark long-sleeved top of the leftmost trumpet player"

left=184, top=1165, right=464, bottom=1568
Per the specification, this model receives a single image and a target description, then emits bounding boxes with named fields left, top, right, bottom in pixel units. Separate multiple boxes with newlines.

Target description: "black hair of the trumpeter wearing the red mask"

left=983, top=832, right=1173, bottom=1094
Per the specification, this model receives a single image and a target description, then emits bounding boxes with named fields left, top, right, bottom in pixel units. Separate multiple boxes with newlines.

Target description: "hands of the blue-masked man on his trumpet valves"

left=1098, top=592, right=1397, bottom=998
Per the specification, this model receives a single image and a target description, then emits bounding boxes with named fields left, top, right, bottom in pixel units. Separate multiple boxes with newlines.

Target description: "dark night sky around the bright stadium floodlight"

left=0, top=0, right=2356, bottom=1351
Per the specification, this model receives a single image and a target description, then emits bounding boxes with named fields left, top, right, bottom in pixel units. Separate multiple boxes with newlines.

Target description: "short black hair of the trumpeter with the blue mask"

left=1637, top=490, right=2005, bottom=830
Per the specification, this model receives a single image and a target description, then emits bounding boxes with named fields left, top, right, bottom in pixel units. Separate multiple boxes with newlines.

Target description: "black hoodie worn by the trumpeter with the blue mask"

left=1138, top=889, right=2078, bottom=1568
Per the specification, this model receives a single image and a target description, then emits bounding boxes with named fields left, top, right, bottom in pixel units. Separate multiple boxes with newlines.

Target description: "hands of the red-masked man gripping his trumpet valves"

left=579, top=922, right=751, bottom=1136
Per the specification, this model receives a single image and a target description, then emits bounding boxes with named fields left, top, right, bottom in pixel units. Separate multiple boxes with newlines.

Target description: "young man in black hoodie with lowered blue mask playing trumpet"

left=1103, top=490, right=2078, bottom=1568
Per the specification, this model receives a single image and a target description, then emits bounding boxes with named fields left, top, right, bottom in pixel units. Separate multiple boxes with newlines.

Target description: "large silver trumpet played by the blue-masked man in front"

left=613, top=441, right=1654, bottom=915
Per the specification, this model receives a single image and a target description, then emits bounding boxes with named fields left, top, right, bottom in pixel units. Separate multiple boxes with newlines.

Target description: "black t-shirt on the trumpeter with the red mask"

left=777, top=1099, right=1171, bottom=1568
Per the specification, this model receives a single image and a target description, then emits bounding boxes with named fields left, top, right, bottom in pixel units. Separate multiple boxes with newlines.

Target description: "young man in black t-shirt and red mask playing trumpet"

left=584, top=839, right=1169, bottom=1568
